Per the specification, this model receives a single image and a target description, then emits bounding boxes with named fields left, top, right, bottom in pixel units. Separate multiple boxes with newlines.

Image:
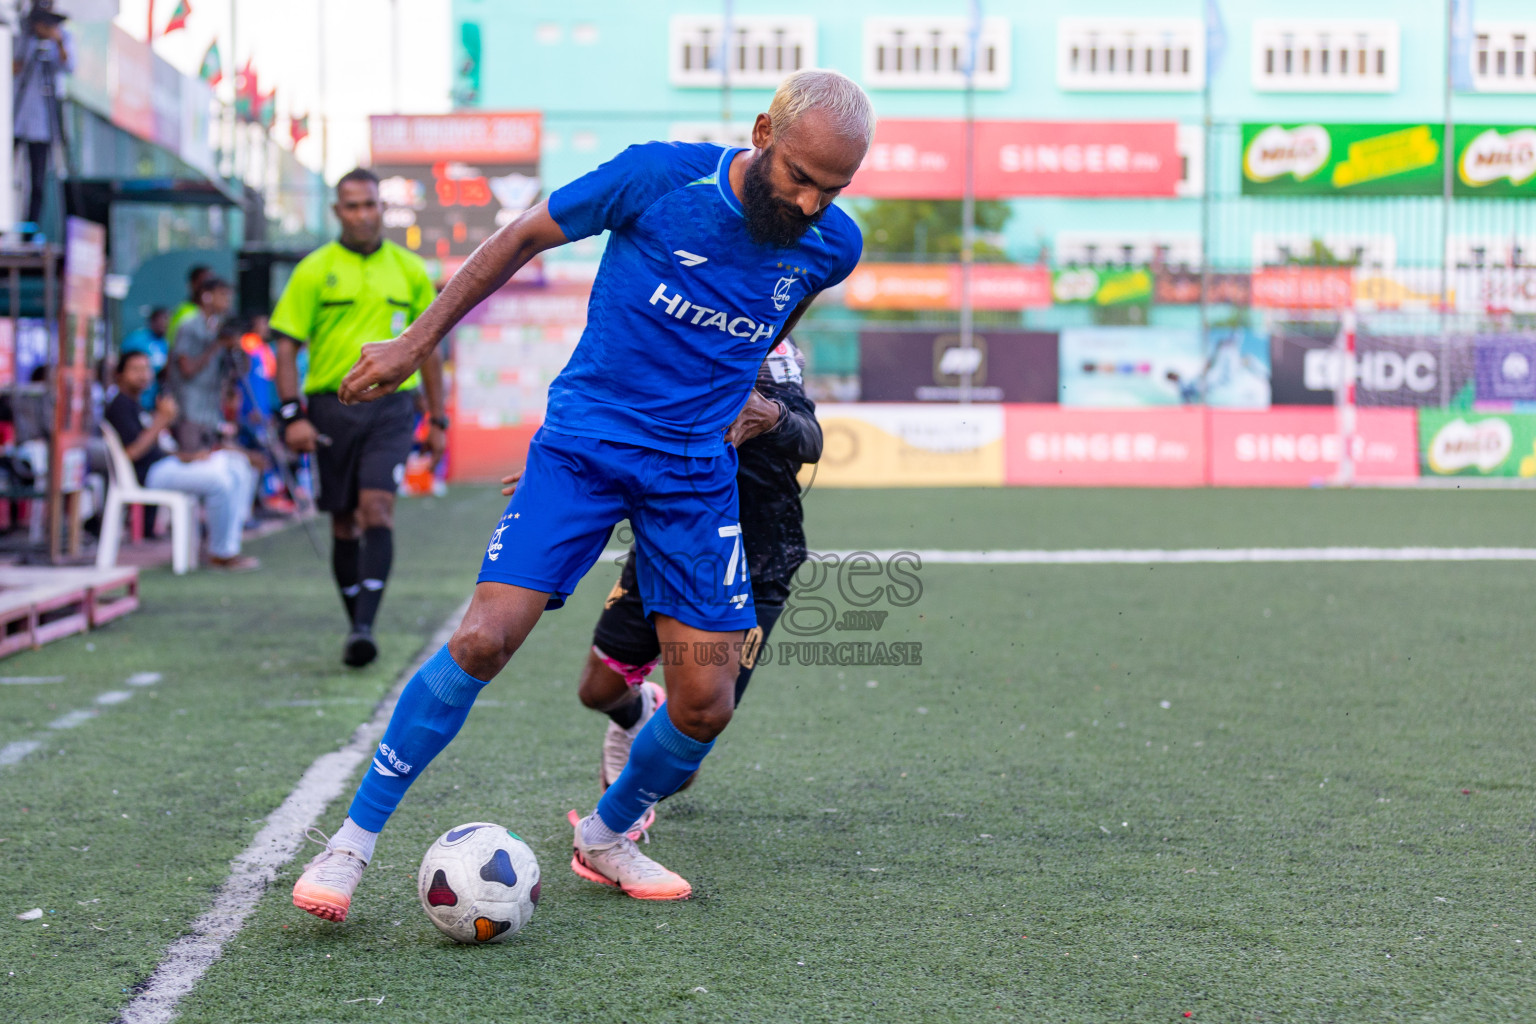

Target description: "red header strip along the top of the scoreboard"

left=369, top=112, right=541, bottom=164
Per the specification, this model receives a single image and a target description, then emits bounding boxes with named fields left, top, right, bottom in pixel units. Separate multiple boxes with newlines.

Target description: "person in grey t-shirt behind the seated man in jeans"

left=166, top=278, right=240, bottom=448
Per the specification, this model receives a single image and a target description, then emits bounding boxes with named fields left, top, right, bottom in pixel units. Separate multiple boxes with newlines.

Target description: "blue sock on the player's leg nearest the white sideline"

left=347, top=645, right=485, bottom=832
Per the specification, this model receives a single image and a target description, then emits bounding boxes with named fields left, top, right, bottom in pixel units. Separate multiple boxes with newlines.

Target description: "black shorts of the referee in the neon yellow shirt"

left=309, top=391, right=416, bottom=513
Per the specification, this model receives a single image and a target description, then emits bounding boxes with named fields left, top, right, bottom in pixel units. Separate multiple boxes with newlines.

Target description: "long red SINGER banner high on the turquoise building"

left=845, top=118, right=1183, bottom=200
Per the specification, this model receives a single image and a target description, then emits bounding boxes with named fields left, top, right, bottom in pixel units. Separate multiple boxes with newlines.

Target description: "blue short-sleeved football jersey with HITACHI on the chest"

left=544, top=143, right=863, bottom=456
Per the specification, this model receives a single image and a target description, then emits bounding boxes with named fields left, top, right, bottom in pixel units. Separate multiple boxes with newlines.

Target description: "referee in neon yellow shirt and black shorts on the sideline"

left=272, top=169, right=449, bottom=666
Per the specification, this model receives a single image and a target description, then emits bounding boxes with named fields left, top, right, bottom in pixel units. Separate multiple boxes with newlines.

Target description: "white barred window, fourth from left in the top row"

left=1250, top=18, right=1402, bottom=94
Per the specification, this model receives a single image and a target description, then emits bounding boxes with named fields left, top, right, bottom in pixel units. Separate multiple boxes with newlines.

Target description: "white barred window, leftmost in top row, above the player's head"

left=667, top=14, right=816, bottom=89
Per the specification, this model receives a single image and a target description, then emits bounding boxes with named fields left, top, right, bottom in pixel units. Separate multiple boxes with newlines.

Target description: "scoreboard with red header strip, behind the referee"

left=369, top=114, right=542, bottom=273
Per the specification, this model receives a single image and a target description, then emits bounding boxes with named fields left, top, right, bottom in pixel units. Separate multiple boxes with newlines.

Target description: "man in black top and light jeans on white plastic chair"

left=106, top=352, right=261, bottom=573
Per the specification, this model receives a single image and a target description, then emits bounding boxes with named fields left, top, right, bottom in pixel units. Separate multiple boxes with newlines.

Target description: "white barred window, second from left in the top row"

left=863, top=17, right=1014, bottom=91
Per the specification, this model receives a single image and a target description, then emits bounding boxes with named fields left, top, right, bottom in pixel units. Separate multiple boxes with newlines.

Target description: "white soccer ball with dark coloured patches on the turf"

left=416, top=821, right=539, bottom=944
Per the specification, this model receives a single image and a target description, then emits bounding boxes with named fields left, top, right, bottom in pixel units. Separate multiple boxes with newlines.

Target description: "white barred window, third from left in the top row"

left=1057, top=17, right=1206, bottom=92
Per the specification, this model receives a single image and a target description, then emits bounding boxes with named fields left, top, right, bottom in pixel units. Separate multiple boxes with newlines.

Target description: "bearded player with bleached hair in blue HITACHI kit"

left=293, top=69, right=874, bottom=921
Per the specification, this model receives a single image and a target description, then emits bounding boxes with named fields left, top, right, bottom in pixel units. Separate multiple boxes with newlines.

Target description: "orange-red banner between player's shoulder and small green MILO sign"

left=843, top=263, right=1051, bottom=310
